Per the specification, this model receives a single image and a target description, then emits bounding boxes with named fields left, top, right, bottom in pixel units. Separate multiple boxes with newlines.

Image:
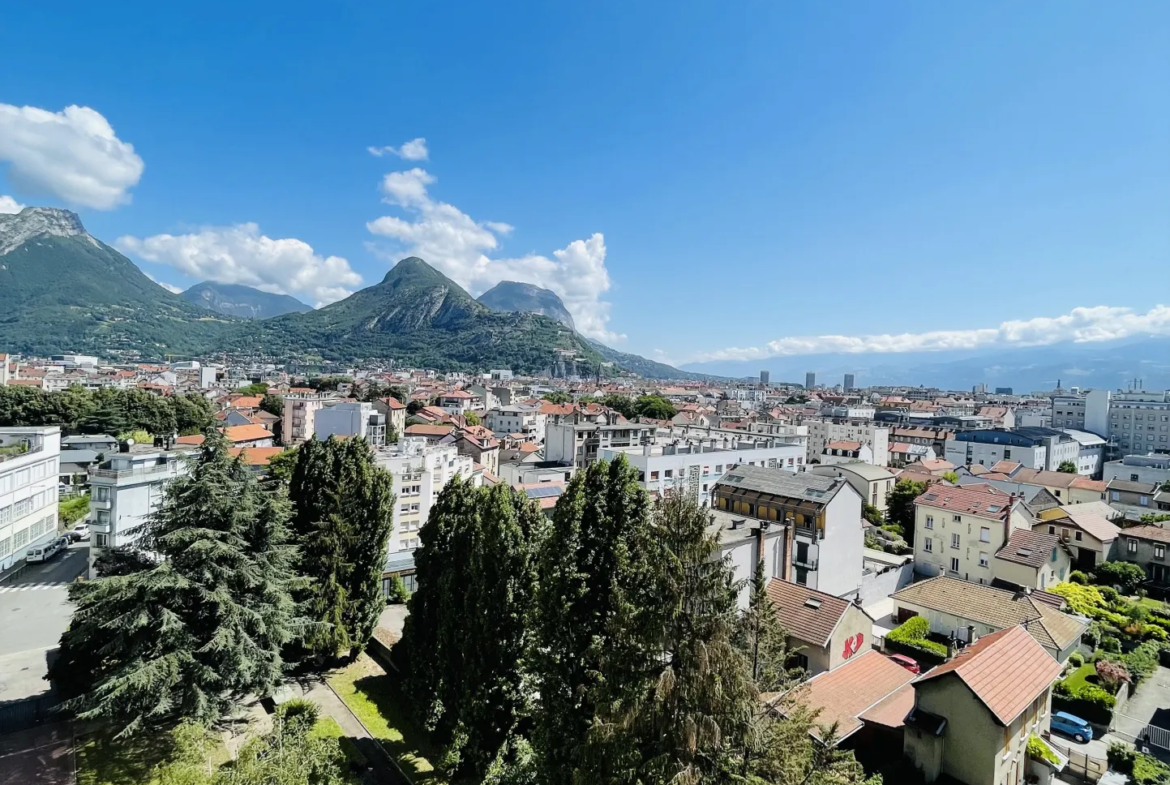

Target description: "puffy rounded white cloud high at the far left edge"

left=0, top=104, right=143, bottom=209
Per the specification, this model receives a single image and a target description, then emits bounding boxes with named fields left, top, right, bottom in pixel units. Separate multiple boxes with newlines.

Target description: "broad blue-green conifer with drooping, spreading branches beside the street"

left=50, top=432, right=297, bottom=736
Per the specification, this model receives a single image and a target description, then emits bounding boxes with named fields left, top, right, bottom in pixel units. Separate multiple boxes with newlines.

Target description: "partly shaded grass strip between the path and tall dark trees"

left=329, top=654, right=445, bottom=785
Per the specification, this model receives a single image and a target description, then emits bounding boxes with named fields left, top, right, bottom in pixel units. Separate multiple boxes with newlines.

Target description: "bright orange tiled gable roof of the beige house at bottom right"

left=915, top=627, right=1060, bottom=725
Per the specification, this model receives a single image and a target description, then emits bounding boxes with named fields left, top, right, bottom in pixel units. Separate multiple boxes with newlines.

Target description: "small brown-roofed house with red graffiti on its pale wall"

left=768, top=578, right=874, bottom=675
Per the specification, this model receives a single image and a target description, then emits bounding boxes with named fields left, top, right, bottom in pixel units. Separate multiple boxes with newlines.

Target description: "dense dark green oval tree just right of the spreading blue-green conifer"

left=289, top=438, right=395, bottom=660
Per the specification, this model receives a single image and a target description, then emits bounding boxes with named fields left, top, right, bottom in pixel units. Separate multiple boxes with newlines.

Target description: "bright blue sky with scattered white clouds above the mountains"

left=0, top=0, right=1170, bottom=361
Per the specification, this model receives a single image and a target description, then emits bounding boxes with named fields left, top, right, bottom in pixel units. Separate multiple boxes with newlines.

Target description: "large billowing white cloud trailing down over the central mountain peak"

left=366, top=168, right=626, bottom=343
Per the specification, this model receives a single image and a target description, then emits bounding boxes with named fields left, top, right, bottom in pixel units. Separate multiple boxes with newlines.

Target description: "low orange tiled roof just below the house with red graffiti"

left=799, top=649, right=915, bottom=739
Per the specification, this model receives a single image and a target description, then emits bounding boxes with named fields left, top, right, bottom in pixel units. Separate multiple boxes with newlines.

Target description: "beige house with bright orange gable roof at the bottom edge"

left=902, top=626, right=1061, bottom=785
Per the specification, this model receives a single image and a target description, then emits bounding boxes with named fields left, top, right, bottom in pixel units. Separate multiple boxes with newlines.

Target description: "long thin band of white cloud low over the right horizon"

left=690, top=305, right=1170, bottom=361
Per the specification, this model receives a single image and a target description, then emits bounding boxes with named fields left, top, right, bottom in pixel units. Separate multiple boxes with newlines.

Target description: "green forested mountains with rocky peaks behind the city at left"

left=0, top=207, right=697, bottom=373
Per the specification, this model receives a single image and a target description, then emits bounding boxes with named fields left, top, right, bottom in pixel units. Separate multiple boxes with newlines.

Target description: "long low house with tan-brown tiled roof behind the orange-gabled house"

left=890, top=576, right=1088, bottom=662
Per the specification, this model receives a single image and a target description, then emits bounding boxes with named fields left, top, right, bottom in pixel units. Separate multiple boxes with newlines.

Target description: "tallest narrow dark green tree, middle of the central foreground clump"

left=530, top=456, right=659, bottom=783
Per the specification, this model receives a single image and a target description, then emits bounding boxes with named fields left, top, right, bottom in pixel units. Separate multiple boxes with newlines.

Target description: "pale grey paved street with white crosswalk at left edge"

left=0, top=543, right=89, bottom=701
